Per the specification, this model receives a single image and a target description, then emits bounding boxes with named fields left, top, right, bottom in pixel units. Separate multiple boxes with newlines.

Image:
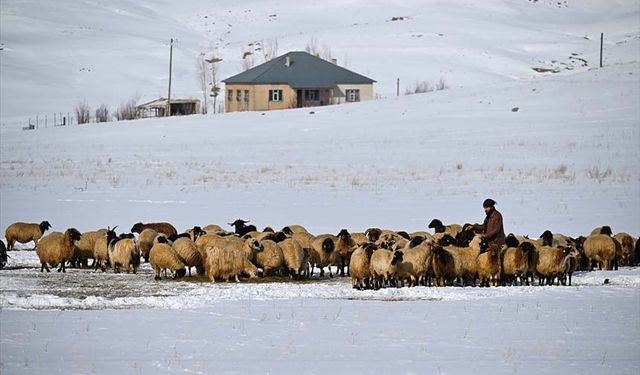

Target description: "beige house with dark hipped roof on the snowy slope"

left=222, top=51, right=376, bottom=112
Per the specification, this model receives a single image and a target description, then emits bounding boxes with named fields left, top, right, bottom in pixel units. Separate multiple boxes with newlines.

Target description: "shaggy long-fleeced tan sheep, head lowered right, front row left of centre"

left=206, top=246, right=257, bottom=283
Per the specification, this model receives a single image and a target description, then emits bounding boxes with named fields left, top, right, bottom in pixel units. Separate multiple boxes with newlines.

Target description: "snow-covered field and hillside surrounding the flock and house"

left=0, top=0, right=640, bottom=374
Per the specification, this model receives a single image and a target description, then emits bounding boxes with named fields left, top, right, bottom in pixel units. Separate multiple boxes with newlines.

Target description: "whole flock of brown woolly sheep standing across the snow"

left=0, top=219, right=640, bottom=289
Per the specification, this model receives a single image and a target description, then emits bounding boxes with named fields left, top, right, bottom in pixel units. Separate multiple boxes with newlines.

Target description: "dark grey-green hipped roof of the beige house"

left=222, top=51, right=375, bottom=89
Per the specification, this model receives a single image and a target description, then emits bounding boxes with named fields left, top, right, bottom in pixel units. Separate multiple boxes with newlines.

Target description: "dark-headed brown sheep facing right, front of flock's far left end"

left=36, top=228, right=81, bottom=272
